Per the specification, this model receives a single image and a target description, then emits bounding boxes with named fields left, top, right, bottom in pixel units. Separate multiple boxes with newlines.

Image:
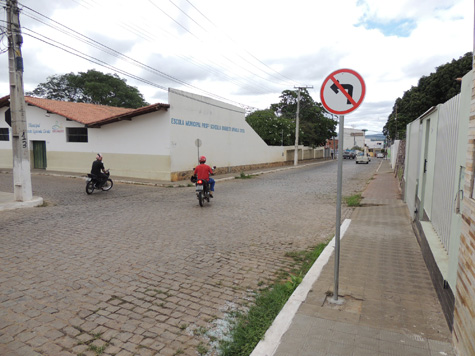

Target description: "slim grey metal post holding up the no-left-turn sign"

left=332, top=115, right=345, bottom=303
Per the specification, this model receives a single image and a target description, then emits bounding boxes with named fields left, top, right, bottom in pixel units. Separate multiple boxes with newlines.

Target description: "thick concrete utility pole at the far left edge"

left=6, top=0, right=33, bottom=201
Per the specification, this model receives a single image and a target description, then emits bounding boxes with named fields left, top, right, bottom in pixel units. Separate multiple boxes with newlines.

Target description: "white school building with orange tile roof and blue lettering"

left=0, top=89, right=323, bottom=181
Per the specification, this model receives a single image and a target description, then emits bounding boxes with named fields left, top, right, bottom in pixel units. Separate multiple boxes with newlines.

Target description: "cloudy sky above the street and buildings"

left=0, top=0, right=474, bottom=134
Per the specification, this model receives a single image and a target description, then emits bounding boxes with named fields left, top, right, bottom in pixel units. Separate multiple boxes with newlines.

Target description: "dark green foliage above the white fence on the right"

left=383, top=52, right=473, bottom=139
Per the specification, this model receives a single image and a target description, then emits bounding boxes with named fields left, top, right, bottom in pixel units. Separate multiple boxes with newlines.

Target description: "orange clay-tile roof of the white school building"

left=0, top=95, right=170, bottom=127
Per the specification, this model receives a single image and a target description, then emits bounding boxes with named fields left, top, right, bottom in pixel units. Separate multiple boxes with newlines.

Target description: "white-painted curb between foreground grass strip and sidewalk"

left=250, top=219, right=351, bottom=356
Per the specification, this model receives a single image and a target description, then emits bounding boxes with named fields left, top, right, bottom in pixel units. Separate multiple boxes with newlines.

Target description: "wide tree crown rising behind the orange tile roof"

left=27, top=69, right=148, bottom=109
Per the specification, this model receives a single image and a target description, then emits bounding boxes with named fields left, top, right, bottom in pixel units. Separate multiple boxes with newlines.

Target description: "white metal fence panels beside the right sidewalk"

left=404, top=94, right=460, bottom=252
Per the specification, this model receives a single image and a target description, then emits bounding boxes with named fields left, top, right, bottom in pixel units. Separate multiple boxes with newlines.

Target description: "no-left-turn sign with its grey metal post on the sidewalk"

left=320, top=69, right=366, bottom=303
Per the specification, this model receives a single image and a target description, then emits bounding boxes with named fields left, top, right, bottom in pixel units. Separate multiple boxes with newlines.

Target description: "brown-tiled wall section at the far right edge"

left=453, top=62, right=475, bottom=356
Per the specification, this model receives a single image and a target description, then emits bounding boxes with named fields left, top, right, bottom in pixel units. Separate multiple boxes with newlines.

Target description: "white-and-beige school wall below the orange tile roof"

left=0, top=106, right=170, bottom=180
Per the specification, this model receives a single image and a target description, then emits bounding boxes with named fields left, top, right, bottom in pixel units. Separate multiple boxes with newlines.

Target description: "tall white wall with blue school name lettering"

left=169, top=89, right=284, bottom=172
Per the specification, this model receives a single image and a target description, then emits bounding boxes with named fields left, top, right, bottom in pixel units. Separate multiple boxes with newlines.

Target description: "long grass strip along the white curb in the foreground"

left=220, top=243, right=327, bottom=356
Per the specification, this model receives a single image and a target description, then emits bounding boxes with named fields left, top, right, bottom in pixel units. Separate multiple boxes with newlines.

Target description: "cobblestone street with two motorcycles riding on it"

left=0, top=159, right=379, bottom=356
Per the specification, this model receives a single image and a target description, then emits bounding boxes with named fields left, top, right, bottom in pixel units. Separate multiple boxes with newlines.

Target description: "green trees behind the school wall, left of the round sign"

left=246, top=89, right=337, bottom=147
